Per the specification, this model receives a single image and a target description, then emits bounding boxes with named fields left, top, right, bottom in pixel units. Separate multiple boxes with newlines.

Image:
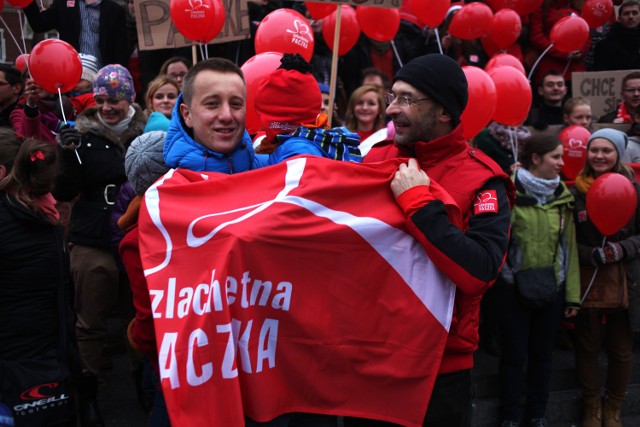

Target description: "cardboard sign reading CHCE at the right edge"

left=571, top=70, right=640, bottom=123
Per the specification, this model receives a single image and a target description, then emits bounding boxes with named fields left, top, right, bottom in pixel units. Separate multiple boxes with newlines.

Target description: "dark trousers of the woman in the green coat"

left=495, top=283, right=564, bottom=421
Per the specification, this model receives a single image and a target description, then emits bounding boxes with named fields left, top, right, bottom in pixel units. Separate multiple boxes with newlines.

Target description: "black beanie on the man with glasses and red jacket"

left=393, top=53, right=469, bottom=125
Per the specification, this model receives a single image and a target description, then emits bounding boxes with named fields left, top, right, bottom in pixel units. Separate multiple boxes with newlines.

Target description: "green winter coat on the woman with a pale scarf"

left=508, top=176, right=580, bottom=308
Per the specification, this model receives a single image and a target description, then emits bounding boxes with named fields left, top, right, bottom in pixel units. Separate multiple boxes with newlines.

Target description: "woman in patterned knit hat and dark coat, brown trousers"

left=53, top=64, right=147, bottom=425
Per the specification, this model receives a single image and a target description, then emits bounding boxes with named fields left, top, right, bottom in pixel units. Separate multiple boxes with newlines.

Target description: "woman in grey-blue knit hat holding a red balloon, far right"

left=571, top=129, right=640, bottom=427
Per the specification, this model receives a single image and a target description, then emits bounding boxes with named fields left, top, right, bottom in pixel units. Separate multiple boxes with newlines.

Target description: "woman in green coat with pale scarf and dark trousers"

left=495, top=134, right=580, bottom=427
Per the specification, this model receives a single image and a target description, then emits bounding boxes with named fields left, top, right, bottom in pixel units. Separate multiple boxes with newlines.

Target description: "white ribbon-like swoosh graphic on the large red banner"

left=145, top=158, right=455, bottom=331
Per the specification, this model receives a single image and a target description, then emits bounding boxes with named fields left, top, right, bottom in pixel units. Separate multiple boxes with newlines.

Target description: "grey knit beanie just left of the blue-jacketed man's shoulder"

left=124, top=130, right=171, bottom=194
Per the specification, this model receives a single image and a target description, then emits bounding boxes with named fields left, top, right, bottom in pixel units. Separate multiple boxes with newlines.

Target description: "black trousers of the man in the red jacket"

left=344, top=369, right=473, bottom=427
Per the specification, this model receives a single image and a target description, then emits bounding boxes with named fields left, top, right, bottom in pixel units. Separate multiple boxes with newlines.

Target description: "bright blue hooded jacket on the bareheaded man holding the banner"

left=164, top=94, right=267, bottom=174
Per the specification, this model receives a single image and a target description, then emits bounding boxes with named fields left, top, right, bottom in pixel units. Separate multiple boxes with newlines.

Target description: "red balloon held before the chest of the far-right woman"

left=587, top=173, right=638, bottom=236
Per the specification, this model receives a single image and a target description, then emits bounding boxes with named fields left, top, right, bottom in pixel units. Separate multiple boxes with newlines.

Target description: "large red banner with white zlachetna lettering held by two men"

left=139, top=157, right=455, bottom=426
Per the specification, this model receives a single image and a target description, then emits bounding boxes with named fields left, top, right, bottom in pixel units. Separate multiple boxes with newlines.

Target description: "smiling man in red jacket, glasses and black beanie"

left=345, top=54, right=515, bottom=427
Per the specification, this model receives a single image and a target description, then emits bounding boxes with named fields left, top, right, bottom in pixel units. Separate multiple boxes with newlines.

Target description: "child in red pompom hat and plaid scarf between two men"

left=255, top=53, right=362, bottom=164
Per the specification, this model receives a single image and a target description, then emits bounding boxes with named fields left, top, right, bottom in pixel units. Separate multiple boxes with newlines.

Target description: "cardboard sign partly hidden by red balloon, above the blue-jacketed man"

left=133, top=0, right=250, bottom=50
